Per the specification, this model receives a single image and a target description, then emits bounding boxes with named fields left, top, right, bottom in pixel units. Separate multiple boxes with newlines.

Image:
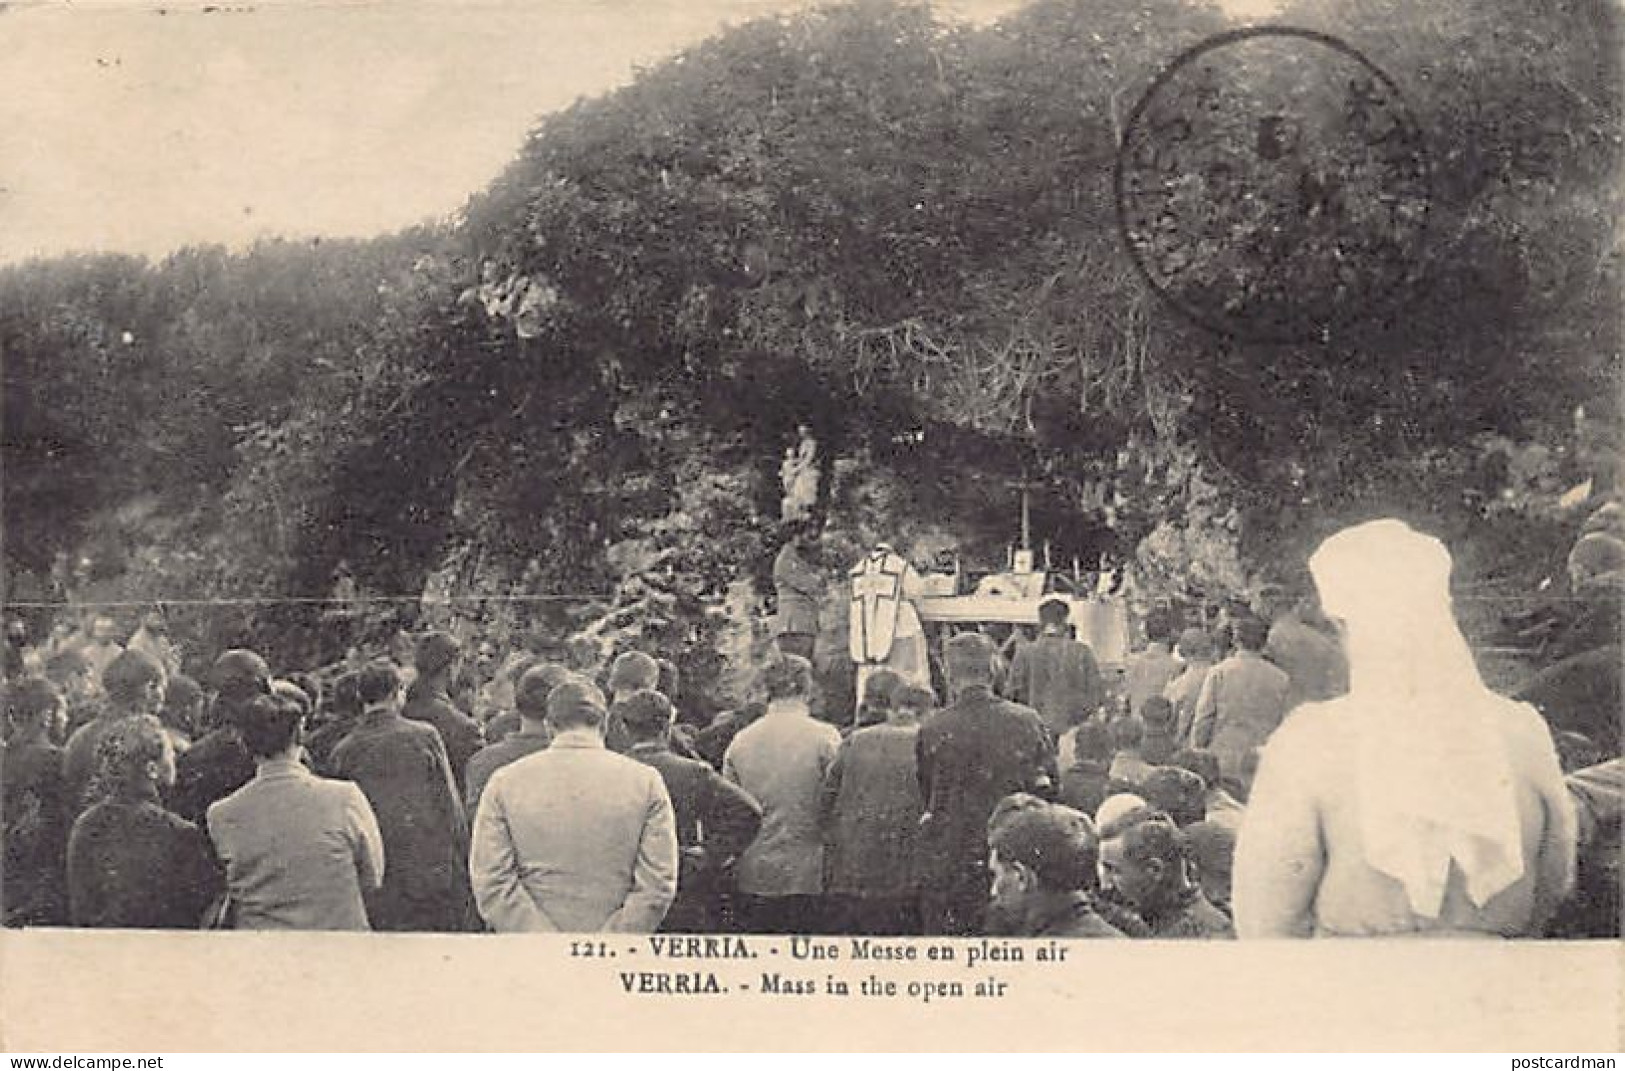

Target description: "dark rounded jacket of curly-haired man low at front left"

left=68, top=791, right=221, bottom=930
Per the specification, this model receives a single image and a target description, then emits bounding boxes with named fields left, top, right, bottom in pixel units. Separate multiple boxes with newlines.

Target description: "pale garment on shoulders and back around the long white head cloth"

left=1233, top=699, right=1575, bottom=938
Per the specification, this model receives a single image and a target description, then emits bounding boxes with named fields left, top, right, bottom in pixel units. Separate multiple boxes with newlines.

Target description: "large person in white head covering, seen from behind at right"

left=1235, top=520, right=1575, bottom=938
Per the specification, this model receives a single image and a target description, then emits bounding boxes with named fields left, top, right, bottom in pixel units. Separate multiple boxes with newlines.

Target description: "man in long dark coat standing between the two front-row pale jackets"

left=332, top=661, right=473, bottom=931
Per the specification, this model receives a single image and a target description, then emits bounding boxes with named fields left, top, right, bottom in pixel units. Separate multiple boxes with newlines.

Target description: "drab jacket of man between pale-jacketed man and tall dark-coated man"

left=824, top=725, right=925, bottom=897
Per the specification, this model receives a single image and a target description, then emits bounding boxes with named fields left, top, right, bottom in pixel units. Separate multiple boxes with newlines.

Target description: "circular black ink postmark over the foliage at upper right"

left=1115, top=26, right=1430, bottom=343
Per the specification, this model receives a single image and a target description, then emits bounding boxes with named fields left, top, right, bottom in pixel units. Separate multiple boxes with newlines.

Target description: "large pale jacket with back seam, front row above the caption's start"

left=468, top=730, right=678, bottom=933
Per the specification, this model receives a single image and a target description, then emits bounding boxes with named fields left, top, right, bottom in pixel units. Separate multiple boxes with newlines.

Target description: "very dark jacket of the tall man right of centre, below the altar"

left=915, top=684, right=1055, bottom=889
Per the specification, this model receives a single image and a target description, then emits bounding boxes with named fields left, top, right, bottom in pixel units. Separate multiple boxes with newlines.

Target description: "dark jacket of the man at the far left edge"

left=0, top=744, right=72, bottom=926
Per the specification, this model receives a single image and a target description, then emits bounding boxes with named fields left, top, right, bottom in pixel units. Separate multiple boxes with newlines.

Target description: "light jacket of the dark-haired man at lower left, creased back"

left=208, top=759, right=385, bottom=930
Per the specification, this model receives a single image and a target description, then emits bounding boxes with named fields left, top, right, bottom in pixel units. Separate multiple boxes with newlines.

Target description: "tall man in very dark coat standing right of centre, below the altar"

left=915, top=632, right=1056, bottom=936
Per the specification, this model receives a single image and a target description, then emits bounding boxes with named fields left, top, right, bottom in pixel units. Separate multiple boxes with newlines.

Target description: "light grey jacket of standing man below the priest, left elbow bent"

left=722, top=705, right=840, bottom=895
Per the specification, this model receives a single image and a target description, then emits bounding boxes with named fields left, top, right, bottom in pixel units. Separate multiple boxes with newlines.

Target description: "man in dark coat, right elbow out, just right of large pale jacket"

left=616, top=691, right=762, bottom=933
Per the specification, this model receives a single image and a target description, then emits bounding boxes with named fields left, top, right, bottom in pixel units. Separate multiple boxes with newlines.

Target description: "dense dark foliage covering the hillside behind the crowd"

left=0, top=0, right=1622, bottom=705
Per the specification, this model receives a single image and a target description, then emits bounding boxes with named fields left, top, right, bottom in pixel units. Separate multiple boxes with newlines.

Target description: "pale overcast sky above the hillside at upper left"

left=0, top=0, right=1255, bottom=263
